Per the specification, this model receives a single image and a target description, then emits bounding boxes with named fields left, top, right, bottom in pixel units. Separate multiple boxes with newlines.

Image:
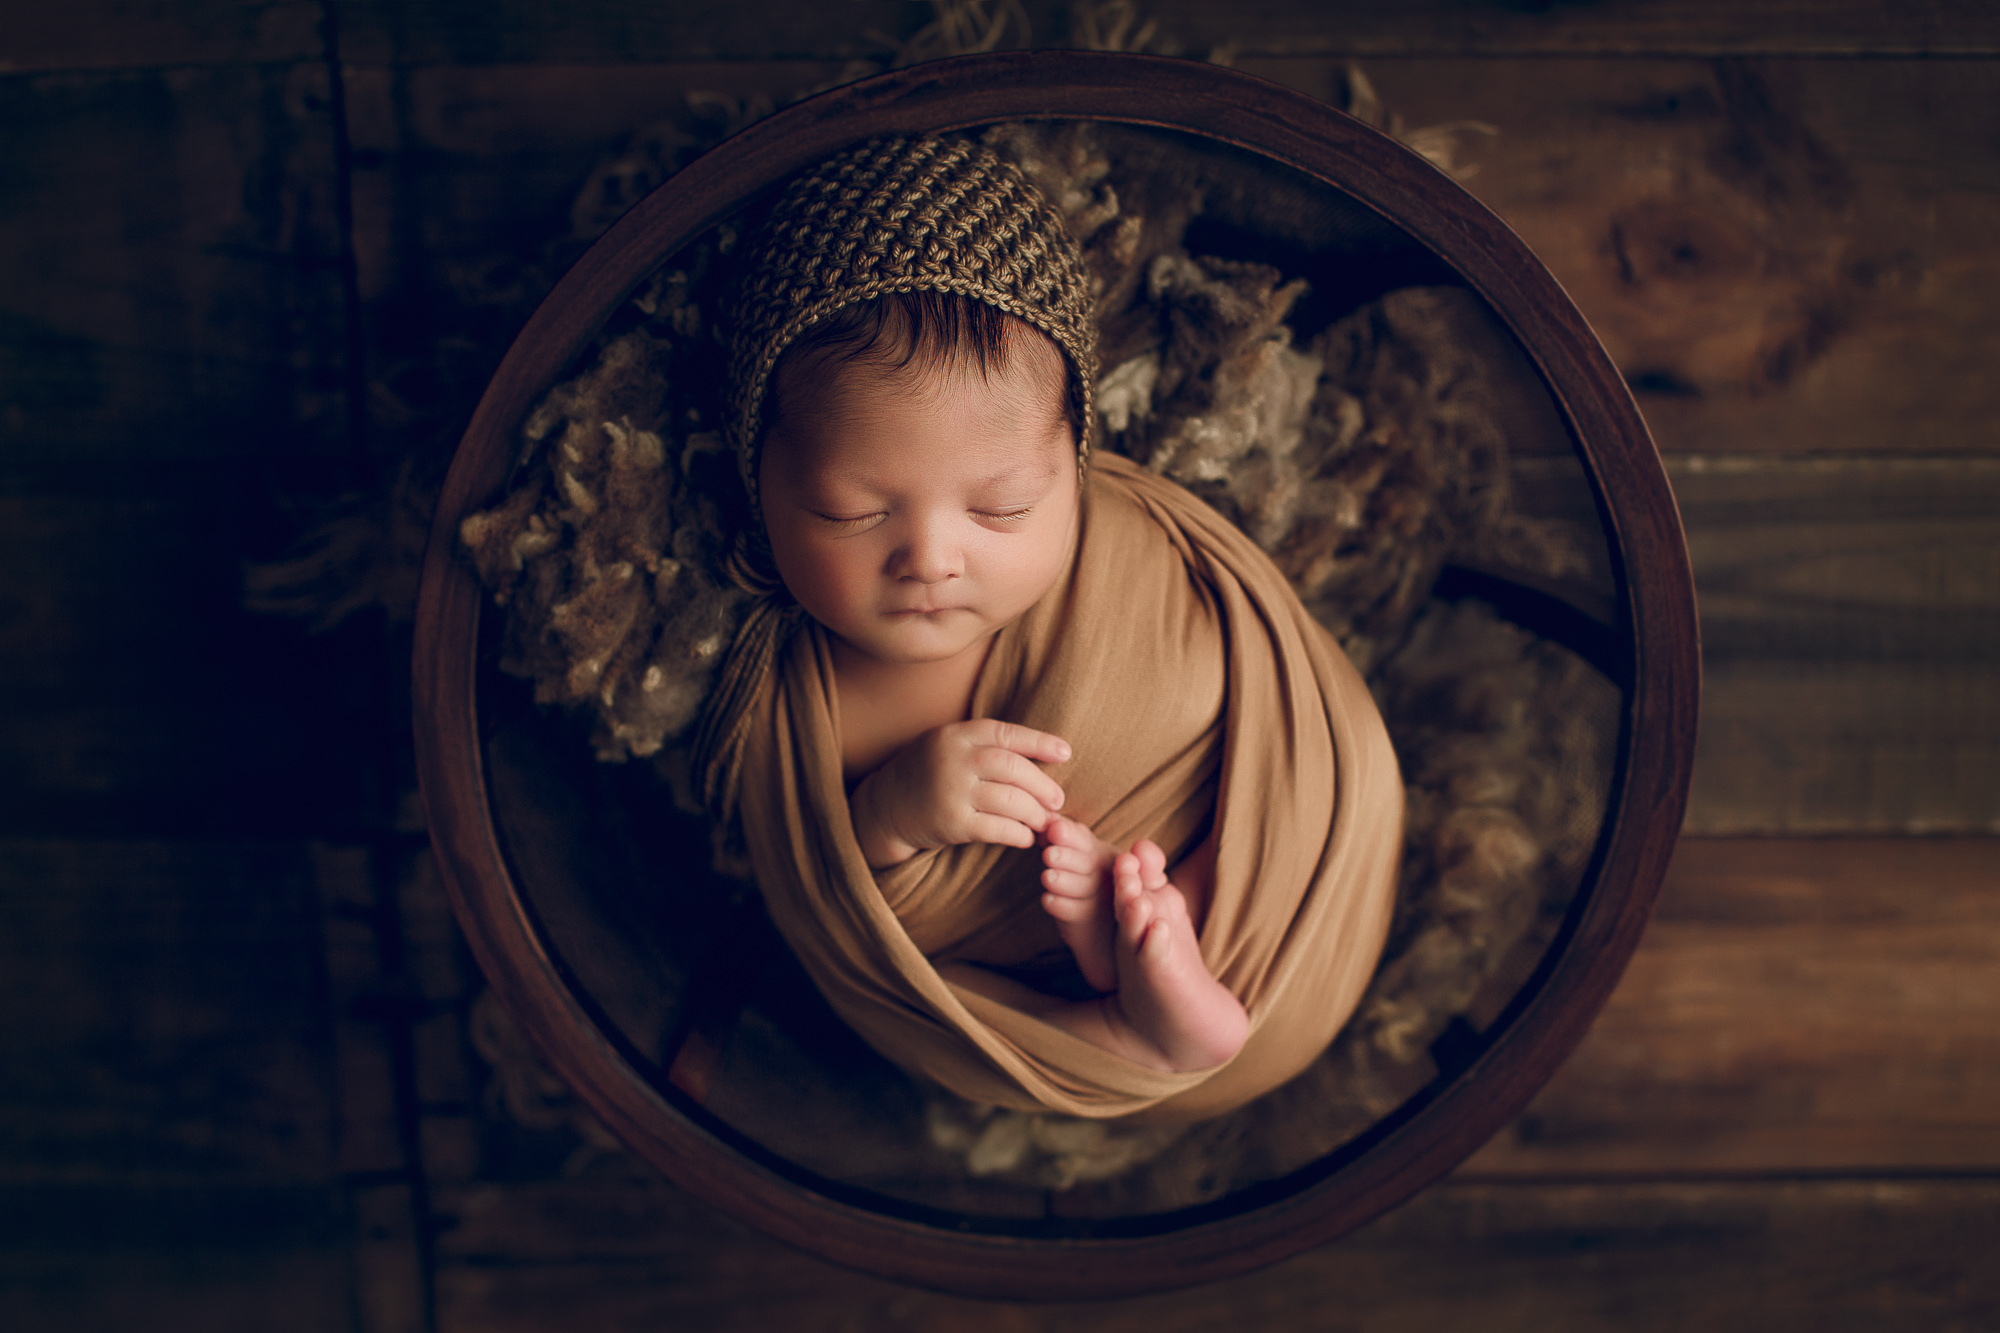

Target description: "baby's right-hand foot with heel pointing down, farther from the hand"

left=1112, top=839, right=1250, bottom=1071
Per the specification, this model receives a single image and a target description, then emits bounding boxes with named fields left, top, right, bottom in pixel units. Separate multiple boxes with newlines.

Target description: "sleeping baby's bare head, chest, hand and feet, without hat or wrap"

left=758, top=292, right=1248, bottom=1071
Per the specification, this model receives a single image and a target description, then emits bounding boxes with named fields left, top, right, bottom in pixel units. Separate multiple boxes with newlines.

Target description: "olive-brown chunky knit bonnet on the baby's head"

left=730, top=138, right=1098, bottom=502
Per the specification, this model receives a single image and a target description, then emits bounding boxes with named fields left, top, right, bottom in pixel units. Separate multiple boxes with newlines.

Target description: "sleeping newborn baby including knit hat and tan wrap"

left=696, top=138, right=1402, bottom=1119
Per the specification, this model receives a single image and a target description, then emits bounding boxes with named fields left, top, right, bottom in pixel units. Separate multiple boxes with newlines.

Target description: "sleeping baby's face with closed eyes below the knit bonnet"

left=758, top=332, right=1078, bottom=664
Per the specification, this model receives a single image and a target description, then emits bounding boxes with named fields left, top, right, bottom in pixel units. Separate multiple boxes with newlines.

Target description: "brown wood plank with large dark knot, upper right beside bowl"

left=1242, top=60, right=2000, bottom=454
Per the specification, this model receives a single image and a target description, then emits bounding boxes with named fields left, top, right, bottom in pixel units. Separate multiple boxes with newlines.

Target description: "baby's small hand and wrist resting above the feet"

left=848, top=717, right=1070, bottom=871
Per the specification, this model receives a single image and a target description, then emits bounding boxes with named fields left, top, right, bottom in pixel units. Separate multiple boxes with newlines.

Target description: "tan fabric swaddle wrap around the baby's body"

left=726, top=456, right=1402, bottom=1119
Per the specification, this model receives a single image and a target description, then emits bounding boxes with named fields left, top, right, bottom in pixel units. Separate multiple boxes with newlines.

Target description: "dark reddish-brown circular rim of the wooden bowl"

left=414, top=52, right=1700, bottom=1299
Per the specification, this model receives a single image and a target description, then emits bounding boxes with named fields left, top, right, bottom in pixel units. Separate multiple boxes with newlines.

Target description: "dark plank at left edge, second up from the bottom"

left=0, top=839, right=334, bottom=1187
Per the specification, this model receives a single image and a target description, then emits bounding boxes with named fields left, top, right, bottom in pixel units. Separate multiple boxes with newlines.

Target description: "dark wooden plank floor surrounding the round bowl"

left=0, top=0, right=2000, bottom=1333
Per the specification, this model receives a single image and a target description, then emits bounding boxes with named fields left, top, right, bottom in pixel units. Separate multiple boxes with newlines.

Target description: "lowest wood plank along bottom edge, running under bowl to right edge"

left=438, top=1179, right=2000, bottom=1333
